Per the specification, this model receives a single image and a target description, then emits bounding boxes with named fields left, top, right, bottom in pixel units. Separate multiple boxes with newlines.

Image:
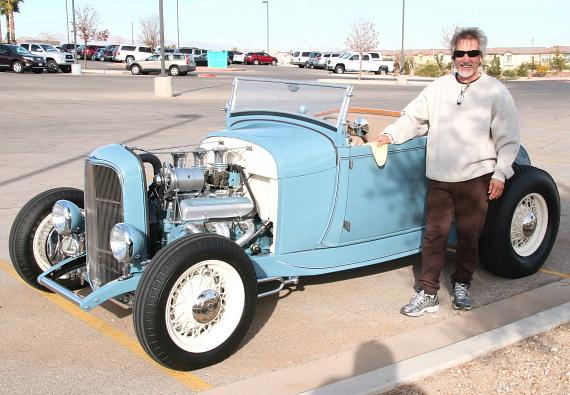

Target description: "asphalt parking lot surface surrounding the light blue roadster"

left=0, top=66, right=570, bottom=393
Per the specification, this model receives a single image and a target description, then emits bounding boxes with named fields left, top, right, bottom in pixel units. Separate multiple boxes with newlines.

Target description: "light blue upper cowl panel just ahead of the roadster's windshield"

left=208, top=121, right=337, bottom=178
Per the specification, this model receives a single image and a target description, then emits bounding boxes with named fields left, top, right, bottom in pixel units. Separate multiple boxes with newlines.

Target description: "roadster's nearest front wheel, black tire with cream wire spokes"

left=133, top=234, right=257, bottom=370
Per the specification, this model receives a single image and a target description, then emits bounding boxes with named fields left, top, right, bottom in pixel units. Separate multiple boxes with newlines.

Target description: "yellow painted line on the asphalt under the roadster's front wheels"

left=0, top=260, right=211, bottom=391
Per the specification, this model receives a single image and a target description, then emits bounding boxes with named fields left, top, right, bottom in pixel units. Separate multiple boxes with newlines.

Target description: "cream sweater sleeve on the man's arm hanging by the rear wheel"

left=491, top=86, right=520, bottom=182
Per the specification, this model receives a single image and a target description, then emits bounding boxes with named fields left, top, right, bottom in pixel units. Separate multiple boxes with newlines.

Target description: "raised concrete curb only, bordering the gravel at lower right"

left=303, top=302, right=570, bottom=395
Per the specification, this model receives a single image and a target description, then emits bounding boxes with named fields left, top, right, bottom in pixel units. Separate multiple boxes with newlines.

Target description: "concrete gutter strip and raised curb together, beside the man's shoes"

left=205, top=279, right=570, bottom=395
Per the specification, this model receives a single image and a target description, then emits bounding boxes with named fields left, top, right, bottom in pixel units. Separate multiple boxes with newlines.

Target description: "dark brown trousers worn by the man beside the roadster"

left=418, top=174, right=491, bottom=295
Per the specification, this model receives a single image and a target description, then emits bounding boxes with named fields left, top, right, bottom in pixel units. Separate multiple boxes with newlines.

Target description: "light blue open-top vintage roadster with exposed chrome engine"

left=9, top=78, right=560, bottom=370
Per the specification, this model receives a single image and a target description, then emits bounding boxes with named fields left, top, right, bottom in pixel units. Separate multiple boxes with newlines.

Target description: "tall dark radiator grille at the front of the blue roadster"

left=85, top=161, right=123, bottom=288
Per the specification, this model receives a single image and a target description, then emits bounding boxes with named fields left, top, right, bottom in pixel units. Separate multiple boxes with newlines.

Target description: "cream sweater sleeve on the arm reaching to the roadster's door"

left=382, top=87, right=429, bottom=144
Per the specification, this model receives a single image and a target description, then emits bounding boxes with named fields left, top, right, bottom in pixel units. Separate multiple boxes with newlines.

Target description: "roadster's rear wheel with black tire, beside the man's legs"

left=479, top=166, right=560, bottom=278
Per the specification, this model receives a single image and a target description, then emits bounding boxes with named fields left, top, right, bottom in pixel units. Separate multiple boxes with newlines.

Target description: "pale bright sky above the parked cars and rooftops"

left=8, top=0, right=570, bottom=52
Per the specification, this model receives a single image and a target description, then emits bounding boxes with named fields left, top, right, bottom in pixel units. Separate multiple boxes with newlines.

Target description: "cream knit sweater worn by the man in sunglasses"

left=383, top=74, right=519, bottom=182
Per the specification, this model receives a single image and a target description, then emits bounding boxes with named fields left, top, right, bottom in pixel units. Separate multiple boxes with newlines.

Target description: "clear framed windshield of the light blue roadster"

left=229, top=78, right=352, bottom=129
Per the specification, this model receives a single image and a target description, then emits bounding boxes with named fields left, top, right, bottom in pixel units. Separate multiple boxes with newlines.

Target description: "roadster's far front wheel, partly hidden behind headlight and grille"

left=9, top=188, right=83, bottom=291
